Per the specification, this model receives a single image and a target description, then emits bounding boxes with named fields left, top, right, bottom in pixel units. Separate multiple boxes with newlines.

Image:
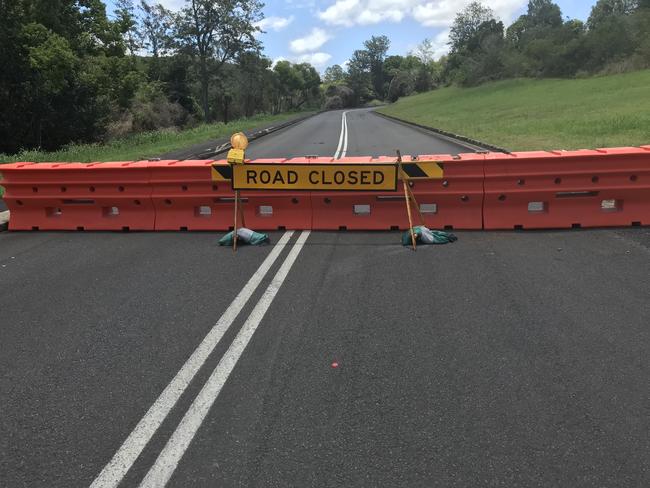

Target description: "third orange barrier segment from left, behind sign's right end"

left=311, top=154, right=485, bottom=230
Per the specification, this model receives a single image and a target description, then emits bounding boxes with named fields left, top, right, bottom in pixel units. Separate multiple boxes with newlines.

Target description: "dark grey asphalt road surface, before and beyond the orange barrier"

left=0, top=111, right=650, bottom=488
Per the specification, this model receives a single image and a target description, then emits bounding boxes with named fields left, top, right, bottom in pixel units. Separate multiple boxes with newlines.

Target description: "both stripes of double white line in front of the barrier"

left=91, top=231, right=309, bottom=488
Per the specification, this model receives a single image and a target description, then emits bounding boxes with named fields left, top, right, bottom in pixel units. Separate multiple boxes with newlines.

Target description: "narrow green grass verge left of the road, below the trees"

left=0, top=112, right=307, bottom=163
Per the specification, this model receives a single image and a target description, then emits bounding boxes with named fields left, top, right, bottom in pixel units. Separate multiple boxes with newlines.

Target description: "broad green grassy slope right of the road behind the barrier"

left=380, top=70, right=650, bottom=151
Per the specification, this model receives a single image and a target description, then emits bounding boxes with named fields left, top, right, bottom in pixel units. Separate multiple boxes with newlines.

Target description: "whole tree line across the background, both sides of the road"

left=0, top=0, right=650, bottom=152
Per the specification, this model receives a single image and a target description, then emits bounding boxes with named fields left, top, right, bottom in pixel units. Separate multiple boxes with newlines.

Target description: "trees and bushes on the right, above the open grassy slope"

left=324, top=0, right=650, bottom=107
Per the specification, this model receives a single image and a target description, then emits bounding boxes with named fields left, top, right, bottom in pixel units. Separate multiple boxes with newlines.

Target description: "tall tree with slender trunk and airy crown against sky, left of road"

left=178, top=0, right=263, bottom=121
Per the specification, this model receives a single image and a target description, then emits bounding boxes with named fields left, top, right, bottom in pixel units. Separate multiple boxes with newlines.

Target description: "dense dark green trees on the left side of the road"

left=0, top=0, right=320, bottom=152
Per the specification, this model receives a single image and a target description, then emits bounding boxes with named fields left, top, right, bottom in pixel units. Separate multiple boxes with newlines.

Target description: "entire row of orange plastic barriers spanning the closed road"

left=0, top=146, right=650, bottom=231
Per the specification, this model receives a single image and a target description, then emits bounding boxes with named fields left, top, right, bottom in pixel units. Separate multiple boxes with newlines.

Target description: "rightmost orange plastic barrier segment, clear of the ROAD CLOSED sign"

left=484, top=146, right=650, bottom=229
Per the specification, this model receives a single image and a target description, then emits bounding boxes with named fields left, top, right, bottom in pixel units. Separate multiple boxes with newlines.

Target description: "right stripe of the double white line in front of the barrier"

left=140, top=230, right=310, bottom=488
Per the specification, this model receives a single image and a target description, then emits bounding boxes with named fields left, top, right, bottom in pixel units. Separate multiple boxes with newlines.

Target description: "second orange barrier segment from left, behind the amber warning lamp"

left=150, top=159, right=311, bottom=231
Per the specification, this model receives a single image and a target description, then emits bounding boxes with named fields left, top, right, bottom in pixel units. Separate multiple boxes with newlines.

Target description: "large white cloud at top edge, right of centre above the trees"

left=318, top=0, right=526, bottom=28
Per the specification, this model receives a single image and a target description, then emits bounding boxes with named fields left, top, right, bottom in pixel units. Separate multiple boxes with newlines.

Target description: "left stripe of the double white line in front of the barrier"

left=90, top=231, right=293, bottom=488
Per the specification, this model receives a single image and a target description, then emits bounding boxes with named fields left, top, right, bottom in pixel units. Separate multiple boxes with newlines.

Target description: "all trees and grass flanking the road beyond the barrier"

left=0, top=0, right=650, bottom=164
